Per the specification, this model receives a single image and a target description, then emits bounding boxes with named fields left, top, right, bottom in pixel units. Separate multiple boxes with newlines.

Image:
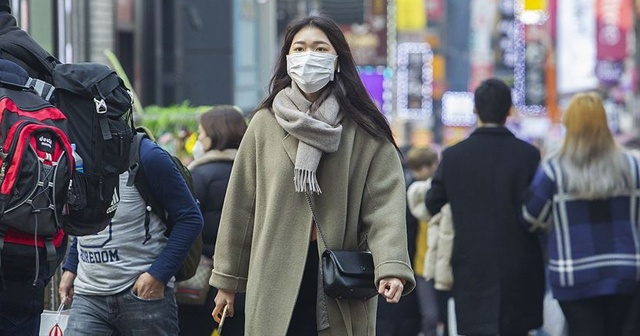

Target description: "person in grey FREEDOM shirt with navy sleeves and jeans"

left=58, top=133, right=203, bottom=336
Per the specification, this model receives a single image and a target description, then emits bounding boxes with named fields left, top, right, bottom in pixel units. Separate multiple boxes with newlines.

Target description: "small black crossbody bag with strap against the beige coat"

left=306, top=194, right=378, bottom=300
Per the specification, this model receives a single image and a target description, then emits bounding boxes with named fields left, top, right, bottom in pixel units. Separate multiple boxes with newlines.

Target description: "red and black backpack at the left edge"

left=0, top=61, right=73, bottom=284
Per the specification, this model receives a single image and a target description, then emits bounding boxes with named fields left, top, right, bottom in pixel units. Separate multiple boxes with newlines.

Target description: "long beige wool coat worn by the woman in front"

left=209, top=110, right=415, bottom=336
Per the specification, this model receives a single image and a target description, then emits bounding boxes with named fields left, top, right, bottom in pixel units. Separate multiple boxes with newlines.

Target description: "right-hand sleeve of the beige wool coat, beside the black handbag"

left=361, top=142, right=415, bottom=295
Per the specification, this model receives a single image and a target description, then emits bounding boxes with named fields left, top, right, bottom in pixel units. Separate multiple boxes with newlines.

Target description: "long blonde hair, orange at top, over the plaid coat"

left=554, top=92, right=631, bottom=199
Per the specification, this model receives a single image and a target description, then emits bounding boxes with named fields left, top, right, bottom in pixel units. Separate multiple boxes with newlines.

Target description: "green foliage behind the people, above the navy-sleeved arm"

left=136, top=101, right=211, bottom=138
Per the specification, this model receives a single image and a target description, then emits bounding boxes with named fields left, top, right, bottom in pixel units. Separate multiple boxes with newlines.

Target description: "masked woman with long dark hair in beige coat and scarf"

left=209, top=16, right=415, bottom=336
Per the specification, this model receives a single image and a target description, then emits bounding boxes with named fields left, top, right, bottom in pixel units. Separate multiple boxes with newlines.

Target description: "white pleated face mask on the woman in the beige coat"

left=287, top=51, right=338, bottom=93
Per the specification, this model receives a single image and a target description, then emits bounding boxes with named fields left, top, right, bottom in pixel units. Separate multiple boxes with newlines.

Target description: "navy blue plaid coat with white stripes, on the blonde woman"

left=523, top=154, right=640, bottom=301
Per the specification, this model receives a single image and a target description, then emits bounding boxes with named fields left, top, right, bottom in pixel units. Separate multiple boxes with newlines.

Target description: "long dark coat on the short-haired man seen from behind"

left=426, top=127, right=545, bottom=335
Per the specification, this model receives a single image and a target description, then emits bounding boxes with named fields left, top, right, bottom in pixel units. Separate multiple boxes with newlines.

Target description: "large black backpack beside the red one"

left=0, top=30, right=134, bottom=236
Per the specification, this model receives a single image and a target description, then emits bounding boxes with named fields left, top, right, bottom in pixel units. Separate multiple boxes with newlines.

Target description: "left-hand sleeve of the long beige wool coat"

left=209, top=117, right=259, bottom=292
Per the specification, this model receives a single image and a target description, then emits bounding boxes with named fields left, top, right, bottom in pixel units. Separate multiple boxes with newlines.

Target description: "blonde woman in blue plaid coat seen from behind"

left=523, top=92, right=640, bottom=336
